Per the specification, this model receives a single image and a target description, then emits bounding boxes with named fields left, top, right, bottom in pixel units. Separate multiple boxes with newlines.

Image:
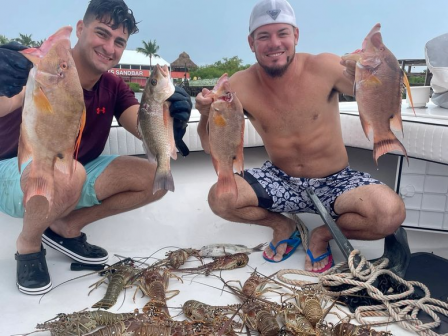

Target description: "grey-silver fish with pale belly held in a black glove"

left=137, top=64, right=177, bottom=194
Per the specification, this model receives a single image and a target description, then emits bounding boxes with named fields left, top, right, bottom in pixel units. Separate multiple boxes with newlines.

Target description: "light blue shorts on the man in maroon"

left=0, top=155, right=118, bottom=218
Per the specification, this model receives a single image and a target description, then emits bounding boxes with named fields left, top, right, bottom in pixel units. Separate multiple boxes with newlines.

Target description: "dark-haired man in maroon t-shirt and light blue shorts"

left=0, top=0, right=191, bottom=294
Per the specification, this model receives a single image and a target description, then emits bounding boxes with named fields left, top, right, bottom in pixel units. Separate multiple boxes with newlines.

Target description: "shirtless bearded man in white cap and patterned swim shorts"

left=196, top=0, right=405, bottom=272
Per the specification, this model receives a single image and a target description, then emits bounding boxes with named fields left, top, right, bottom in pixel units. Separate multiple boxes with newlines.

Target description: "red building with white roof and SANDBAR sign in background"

left=109, top=50, right=194, bottom=87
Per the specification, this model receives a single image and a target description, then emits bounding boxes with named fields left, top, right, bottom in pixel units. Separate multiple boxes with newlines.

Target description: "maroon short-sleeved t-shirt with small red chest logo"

left=0, top=73, right=138, bottom=164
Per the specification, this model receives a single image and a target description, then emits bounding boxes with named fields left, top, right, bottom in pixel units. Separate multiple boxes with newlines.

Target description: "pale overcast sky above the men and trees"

left=0, top=0, right=448, bottom=65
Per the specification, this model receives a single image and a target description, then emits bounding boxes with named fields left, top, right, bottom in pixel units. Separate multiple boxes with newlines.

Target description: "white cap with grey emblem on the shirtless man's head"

left=249, top=0, right=297, bottom=35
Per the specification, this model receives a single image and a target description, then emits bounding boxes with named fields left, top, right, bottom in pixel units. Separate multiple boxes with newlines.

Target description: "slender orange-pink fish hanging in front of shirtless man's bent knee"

left=207, top=74, right=244, bottom=199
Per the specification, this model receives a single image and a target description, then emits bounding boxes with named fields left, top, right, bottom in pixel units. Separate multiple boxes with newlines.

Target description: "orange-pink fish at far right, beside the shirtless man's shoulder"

left=342, top=23, right=410, bottom=164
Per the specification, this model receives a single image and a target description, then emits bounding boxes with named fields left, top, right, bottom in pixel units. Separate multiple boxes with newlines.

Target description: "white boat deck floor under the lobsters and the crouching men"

left=0, top=147, right=448, bottom=335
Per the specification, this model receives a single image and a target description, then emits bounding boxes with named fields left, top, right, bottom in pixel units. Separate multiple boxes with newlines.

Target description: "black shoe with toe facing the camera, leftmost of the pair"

left=15, top=246, right=52, bottom=295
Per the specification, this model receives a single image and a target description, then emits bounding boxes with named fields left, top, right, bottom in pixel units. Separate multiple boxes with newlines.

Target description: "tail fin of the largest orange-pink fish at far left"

left=23, top=159, right=54, bottom=212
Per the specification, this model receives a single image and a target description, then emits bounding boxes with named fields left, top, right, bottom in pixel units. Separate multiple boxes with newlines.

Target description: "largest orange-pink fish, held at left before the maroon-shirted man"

left=18, top=27, right=86, bottom=211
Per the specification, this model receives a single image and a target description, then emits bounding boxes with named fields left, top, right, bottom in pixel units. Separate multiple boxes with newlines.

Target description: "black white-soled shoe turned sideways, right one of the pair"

left=42, top=228, right=109, bottom=264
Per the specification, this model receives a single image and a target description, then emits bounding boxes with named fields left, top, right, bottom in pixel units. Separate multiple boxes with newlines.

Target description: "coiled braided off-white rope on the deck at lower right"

left=277, top=250, right=448, bottom=336
